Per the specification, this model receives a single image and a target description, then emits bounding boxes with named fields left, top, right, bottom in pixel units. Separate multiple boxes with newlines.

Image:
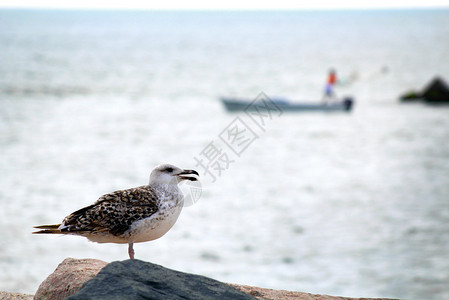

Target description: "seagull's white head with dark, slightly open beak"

left=150, top=164, right=199, bottom=185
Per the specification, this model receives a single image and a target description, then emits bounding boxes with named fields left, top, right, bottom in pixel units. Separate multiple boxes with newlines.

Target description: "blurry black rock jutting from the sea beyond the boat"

left=400, top=77, right=449, bottom=104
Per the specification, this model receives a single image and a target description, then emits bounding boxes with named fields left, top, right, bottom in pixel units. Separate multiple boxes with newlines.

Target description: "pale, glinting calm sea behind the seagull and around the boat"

left=0, top=10, right=449, bottom=299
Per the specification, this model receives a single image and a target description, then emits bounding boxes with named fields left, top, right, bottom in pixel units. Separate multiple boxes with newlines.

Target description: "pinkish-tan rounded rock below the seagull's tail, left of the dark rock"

left=34, top=258, right=107, bottom=300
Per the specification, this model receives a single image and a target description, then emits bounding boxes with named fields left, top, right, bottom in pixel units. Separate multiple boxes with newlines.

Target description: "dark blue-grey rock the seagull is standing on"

left=67, top=259, right=255, bottom=300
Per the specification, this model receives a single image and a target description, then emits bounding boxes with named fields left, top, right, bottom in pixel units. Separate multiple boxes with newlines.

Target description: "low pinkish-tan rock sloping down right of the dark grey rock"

left=230, top=284, right=392, bottom=300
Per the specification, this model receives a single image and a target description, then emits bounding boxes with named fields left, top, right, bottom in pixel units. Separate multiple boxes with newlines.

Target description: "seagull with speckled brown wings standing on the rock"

left=33, top=164, right=199, bottom=259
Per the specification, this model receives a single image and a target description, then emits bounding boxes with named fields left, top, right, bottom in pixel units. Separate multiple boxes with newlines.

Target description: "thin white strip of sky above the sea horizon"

left=0, top=0, right=449, bottom=10
